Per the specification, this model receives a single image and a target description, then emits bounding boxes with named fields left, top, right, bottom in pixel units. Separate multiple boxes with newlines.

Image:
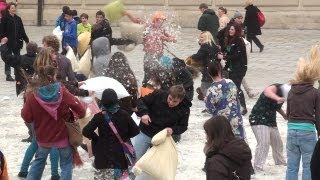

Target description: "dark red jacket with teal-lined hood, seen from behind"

left=21, top=82, right=86, bottom=148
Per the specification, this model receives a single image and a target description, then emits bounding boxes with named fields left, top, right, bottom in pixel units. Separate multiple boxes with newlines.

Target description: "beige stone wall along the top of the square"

left=18, top=0, right=320, bottom=29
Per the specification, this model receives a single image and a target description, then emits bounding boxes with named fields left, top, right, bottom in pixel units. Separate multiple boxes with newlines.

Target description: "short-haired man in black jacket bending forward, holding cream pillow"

left=134, top=85, right=192, bottom=159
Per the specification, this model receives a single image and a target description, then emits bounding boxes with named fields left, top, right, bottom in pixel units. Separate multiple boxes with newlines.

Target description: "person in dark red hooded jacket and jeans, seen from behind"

left=21, top=65, right=85, bottom=179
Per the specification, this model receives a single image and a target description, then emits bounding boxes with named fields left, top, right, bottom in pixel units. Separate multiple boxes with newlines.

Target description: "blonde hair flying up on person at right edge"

left=291, top=45, right=320, bottom=84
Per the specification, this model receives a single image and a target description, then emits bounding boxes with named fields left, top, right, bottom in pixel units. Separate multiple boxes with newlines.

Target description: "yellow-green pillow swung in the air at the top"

left=102, top=0, right=124, bottom=22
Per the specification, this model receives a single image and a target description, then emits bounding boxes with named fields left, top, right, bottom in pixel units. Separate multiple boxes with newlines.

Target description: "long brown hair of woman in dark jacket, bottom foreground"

left=203, top=116, right=235, bottom=152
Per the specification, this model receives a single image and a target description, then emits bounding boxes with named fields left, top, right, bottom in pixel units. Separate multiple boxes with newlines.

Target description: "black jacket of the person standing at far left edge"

left=0, top=15, right=29, bottom=51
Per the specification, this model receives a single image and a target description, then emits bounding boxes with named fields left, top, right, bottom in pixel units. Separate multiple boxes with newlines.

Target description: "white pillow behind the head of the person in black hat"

left=80, top=76, right=130, bottom=99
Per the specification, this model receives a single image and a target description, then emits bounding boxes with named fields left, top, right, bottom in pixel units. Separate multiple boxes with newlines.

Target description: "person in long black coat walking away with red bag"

left=243, top=4, right=264, bottom=52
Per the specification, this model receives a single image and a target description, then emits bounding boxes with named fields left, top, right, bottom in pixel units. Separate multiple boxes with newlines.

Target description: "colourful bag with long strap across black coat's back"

left=104, top=113, right=136, bottom=166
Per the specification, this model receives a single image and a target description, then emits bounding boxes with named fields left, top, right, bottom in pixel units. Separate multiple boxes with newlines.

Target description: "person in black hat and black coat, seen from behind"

left=82, top=89, right=139, bottom=180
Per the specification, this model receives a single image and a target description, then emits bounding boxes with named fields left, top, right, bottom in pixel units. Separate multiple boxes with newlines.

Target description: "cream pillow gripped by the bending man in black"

left=132, top=129, right=178, bottom=180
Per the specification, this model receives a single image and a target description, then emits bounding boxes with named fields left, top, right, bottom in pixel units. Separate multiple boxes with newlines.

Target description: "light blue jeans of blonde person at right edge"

left=286, top=130, right=317, bottom=180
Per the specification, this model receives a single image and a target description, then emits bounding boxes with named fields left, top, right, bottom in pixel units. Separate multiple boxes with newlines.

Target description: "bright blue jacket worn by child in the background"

left=62, top=20, right=78, bottom=48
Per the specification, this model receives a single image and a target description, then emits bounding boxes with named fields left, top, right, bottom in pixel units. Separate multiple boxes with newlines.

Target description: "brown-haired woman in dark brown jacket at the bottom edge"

left=203, top=116, right=252, bottom=180
